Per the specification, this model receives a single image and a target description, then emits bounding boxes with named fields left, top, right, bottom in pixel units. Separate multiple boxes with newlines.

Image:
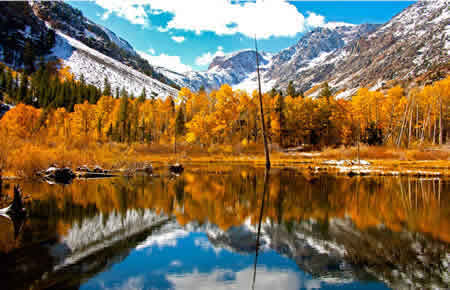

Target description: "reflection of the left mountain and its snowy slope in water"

left=0, top=209, right=169, bottom=289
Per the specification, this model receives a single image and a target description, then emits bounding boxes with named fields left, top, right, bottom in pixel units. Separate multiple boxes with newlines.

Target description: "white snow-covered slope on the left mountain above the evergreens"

left=50, top=31, right=178, bottom=98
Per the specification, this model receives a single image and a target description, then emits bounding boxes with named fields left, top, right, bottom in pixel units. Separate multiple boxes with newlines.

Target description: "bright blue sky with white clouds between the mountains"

left=66, top=0, right=414, bottom=73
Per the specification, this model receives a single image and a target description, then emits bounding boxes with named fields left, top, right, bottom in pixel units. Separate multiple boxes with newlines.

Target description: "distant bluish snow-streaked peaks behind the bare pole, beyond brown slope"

left=159, top=23, right=377, bottom=91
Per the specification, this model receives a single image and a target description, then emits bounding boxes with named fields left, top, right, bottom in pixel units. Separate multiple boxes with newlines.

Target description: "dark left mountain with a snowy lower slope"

left=0, top=1, right=178, bottom=97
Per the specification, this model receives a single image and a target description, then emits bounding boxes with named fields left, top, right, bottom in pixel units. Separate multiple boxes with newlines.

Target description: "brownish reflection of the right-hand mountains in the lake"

left=209, top=219, right=450, bottom=289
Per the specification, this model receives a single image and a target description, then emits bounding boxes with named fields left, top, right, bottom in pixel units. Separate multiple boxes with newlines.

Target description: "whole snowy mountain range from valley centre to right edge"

left=161, top=1, right=450, bottom=96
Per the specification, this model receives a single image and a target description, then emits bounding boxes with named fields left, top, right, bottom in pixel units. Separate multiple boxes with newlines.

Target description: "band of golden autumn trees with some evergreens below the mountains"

left=0, top=63, right=450, bottom=148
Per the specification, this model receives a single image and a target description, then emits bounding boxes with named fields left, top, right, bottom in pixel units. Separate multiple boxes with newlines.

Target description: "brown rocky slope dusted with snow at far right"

left=268, top=1, right=450, bottom=95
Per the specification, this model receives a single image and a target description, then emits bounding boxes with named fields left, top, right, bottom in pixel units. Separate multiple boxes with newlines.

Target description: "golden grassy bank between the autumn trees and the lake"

left=0, top=140, right=450, bottom=178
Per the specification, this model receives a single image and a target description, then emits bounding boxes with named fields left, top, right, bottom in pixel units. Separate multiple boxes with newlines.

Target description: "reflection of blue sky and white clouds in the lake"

left=81, top=230, right=386, bottom=290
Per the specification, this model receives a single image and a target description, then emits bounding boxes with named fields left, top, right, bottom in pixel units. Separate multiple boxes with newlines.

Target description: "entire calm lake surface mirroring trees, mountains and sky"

left=0, top=166, right=450, bottom=290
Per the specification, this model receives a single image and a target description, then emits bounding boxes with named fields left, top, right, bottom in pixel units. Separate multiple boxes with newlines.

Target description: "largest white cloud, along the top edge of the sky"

left=95, top=0, right=342, bottom=38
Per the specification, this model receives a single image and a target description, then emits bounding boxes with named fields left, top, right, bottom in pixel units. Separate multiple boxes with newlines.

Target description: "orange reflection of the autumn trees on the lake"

left=4, top=166, right=450, bottom=242
